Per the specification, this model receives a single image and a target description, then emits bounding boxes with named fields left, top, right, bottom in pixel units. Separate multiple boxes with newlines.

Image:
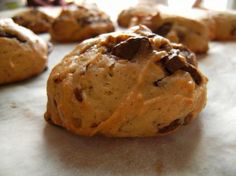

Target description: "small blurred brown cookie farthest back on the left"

left=12, top=8, right=53, bottom=34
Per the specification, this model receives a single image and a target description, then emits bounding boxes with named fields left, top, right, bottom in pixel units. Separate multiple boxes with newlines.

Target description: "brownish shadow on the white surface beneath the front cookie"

left=41, top=118, right=202, bottom=175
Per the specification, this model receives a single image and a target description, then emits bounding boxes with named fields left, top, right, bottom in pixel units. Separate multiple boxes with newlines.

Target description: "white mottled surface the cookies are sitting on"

left=0, top=5, right=236, bottom=176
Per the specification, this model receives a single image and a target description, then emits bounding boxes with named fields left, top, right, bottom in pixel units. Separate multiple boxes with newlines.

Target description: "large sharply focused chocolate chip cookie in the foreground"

left=45, top=26, right=207, bottom=137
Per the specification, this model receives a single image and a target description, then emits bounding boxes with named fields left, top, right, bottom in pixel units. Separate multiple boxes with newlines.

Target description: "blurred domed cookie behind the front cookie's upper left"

left=50, top=5, right=114, bottom=42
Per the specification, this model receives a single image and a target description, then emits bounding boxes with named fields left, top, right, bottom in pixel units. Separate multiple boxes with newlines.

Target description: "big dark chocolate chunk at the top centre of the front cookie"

left=111, top=37, right=151, bottom=60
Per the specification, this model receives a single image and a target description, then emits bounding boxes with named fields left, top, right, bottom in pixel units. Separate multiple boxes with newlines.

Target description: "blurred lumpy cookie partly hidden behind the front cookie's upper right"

left=118, top=6, right=208, bottom=53
